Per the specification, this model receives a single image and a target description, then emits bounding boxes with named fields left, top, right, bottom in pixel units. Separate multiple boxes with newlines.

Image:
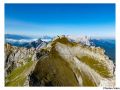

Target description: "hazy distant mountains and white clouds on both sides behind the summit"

left=5, top=34, right=115, bottom=62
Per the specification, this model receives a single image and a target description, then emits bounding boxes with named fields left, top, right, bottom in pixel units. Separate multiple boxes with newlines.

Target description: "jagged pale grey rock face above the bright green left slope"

left=5, top=44, right=34, bottom=75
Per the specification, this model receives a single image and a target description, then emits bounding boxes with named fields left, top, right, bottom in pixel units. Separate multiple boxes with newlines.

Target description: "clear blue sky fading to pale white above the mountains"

left=5, top=4, right=115, bottom=38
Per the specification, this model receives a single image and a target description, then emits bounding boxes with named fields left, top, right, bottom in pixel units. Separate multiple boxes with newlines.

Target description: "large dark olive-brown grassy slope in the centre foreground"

left=34, top=53, right=78, bottom=86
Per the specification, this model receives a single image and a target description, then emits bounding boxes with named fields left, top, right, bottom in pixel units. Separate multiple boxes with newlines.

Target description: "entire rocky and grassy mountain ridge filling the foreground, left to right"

left=5, top=35, right=115, bottom=87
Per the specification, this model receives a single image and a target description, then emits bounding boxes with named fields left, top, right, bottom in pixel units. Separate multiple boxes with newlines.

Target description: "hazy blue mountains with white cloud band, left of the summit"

left=5, top=34, right=52, bottom=48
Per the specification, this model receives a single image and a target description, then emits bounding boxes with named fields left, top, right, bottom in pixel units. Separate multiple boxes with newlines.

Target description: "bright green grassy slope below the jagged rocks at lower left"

left=5, top=61, right=34, bottom=86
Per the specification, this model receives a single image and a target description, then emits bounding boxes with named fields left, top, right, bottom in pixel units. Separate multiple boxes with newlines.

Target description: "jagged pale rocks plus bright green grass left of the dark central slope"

left=5, top=44, right=47, bottom=86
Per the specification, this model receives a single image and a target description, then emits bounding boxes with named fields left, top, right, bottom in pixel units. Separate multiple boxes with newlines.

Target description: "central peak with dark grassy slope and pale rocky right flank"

left=28, top=36, right=114, bottom=86
